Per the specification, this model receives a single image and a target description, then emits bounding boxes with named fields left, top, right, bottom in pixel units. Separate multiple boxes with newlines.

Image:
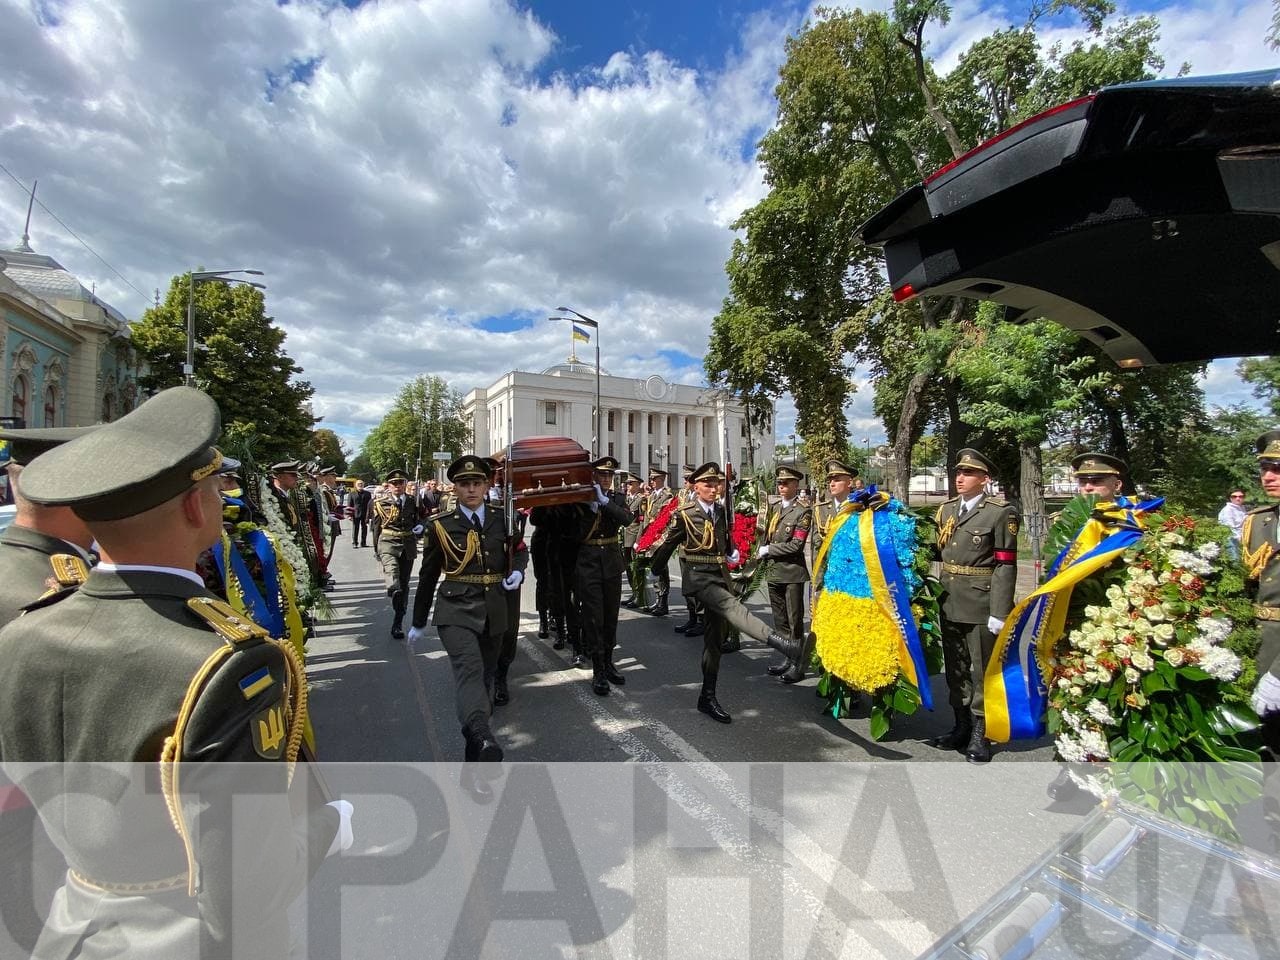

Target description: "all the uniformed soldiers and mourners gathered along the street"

left=0, top=388, right=1280, bottom=956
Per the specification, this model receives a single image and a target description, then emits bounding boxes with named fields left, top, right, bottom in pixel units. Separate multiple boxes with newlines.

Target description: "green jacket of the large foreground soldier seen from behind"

left=0, top=570, right=339, bottom=957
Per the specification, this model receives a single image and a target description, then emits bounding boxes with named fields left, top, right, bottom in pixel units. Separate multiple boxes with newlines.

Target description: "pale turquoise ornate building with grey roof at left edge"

left=0, top=242, right=143, bottom=426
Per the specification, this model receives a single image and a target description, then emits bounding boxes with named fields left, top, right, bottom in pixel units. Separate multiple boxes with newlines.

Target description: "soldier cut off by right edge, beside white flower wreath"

left=1240, top=430, right=1280, bottom=759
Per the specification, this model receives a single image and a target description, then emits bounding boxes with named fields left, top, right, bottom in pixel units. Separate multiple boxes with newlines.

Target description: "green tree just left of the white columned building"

left=361, top=376, right=471, bottom=477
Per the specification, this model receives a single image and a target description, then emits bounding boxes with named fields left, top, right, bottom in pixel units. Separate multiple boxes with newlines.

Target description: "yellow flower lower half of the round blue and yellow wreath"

left=813, top=591, right=899, bottom=692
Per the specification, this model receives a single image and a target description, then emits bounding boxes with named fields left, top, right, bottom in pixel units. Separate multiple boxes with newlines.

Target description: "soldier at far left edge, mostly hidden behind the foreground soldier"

left=0, top=426, right=95, bottom=627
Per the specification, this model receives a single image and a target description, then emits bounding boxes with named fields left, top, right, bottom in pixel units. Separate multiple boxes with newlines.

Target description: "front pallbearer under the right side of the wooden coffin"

left=575, top=457, right=634, bottom=696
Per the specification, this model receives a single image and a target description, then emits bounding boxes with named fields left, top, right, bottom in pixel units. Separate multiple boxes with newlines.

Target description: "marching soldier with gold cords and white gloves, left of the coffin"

left=410, top=456, right=529, bottom=800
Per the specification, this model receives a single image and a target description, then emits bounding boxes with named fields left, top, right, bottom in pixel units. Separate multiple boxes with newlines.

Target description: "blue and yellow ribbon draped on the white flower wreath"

left=983, top=497, right=1165, bottom=744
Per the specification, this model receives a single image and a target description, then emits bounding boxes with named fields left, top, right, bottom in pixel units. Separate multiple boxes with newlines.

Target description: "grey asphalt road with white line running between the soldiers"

left=297, top=540, right=1088, bottom=960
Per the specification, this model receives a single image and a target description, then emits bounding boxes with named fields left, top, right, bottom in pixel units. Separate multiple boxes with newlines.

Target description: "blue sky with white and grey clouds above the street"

left=0, top=0, right=1277, bottom=445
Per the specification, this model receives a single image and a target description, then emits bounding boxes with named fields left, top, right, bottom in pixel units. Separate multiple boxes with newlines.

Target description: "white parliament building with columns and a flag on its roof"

left=462, top=356, right=773, bottom=486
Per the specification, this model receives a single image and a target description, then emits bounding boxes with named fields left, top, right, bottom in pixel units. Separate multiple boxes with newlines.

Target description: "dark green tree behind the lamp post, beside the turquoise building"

left=132, top=274, right=315, bottom=463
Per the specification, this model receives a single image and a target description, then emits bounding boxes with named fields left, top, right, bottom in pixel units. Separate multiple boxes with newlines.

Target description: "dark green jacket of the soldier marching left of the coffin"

left=413, top=503, right=529, bottom=636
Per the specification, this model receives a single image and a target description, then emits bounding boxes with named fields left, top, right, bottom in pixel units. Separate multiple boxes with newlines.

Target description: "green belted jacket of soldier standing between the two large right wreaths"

left=937, top=495, right=1019, bottom=623
